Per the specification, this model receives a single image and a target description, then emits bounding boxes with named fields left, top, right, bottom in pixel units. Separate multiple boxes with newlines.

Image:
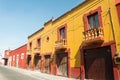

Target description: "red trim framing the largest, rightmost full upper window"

left=83, top=6, right=103, bottom=31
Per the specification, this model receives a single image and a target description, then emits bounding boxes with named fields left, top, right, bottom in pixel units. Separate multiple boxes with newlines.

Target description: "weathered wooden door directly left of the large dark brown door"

left=57, top=53, right=68, bottom=76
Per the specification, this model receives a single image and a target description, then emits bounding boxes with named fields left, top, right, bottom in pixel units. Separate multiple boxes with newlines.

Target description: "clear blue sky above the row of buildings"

left=0, top=0, right=83, bottom=59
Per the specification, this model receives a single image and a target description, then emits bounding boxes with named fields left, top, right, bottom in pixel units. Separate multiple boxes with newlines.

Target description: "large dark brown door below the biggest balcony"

left=84, top=47, right=114, bottom=80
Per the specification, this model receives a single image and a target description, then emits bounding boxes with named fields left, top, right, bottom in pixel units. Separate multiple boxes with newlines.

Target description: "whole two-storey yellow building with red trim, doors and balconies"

left=27, top=0, right=120, bottom=80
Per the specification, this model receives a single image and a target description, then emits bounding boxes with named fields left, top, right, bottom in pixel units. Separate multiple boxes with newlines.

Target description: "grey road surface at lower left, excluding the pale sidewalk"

left=0, top=66, right=40, bottom=80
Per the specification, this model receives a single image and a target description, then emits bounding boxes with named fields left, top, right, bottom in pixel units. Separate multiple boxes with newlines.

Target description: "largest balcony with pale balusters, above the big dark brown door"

left=83, top=27, right=104, bottom=44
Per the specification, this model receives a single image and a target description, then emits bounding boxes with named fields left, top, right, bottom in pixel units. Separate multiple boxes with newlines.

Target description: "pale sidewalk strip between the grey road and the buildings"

left=5, top=66, right=76, bottom=80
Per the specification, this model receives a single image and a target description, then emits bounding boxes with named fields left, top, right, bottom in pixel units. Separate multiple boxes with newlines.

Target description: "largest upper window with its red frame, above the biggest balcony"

left=84, top=7, right=103, bottom=31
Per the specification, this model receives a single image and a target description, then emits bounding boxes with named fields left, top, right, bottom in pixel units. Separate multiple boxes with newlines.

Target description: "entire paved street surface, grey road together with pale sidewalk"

left=0, top=65, right=76, bottom=80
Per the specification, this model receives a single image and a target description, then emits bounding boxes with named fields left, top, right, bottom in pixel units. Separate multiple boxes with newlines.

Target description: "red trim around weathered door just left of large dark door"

left=55, top=49, right=71, bottom=77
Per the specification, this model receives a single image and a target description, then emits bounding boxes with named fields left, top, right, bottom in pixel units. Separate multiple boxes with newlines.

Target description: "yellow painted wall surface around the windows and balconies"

left=28, top=0, right=120, bottom=67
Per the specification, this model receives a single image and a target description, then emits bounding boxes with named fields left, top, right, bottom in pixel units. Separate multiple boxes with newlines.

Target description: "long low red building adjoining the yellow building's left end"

left=9, top=44, right=27, bottom=68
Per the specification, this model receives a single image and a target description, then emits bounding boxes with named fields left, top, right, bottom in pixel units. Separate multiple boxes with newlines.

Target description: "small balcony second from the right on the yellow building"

left=55, top=39, right=67, bottom=49
